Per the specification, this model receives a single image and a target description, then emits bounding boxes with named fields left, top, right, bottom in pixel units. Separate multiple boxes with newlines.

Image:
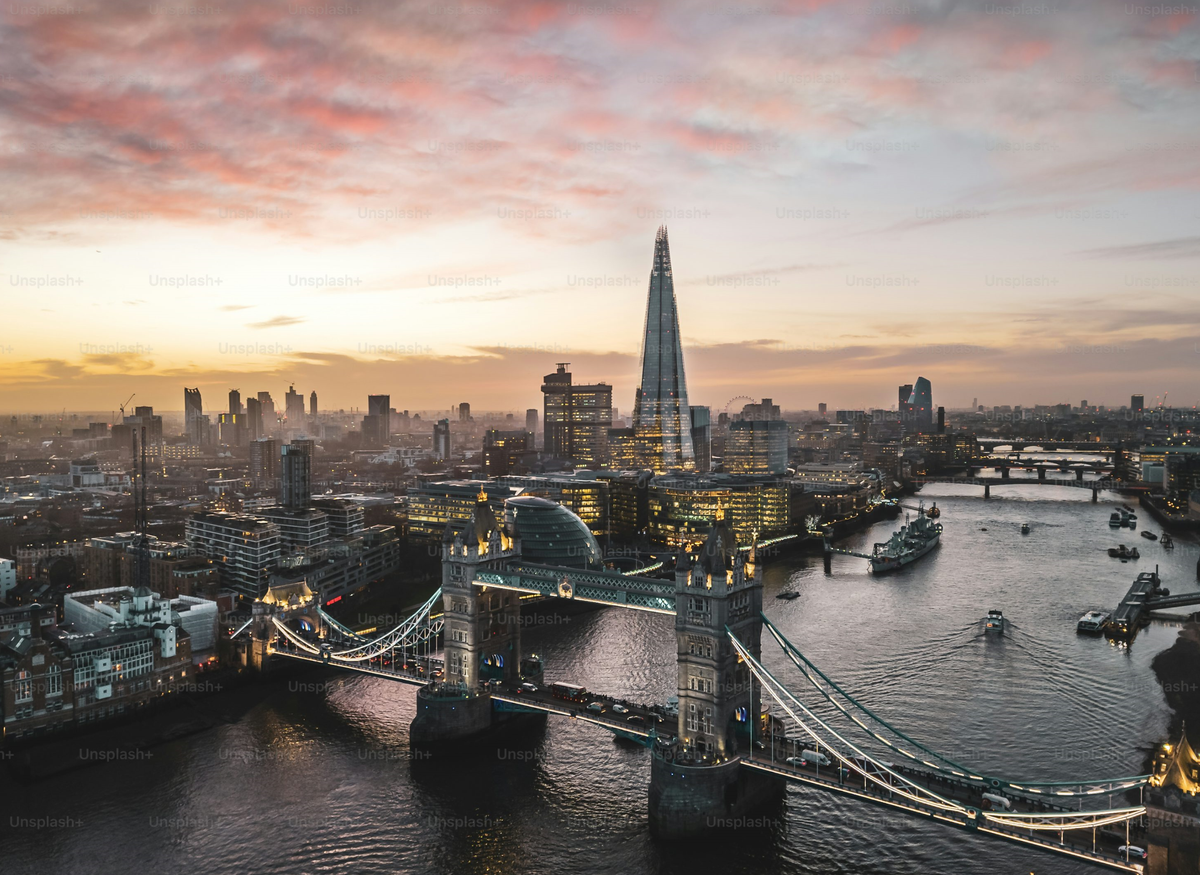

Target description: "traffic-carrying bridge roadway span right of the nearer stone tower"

left=742, top=737, right=1144, bottom=873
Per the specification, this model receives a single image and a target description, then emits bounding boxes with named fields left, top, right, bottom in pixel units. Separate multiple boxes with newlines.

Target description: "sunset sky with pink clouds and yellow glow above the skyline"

left=0, top=0, right=1200, bottom=413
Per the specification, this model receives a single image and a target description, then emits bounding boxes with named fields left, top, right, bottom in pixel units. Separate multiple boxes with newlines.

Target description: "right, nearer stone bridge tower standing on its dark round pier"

left=649, top=510, right=782, bottom=839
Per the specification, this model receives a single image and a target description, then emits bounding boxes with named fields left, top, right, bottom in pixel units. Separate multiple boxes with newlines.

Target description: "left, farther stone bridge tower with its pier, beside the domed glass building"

left=409, top=491, right=521, bottom=745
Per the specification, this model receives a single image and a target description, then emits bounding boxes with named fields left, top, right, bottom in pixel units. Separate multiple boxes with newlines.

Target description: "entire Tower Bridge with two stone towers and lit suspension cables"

left=243, top=495, right=1148, bottom=871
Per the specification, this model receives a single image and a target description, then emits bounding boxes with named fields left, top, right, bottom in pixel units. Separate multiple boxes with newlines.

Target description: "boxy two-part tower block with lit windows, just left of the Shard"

left=541, top=361, right=612, bottom=465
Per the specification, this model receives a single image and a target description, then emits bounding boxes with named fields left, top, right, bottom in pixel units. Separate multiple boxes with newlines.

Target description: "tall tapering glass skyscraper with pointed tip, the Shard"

left=634, top=226, right=696, bottom=471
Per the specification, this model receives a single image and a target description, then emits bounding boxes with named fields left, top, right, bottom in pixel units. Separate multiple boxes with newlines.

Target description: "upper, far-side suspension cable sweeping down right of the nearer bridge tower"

left=762, top=616, right=1150, bottom=797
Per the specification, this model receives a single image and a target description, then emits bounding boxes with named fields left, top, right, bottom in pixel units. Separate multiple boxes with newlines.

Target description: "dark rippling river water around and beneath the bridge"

left=0, top=485, right=1196, bottom=875
